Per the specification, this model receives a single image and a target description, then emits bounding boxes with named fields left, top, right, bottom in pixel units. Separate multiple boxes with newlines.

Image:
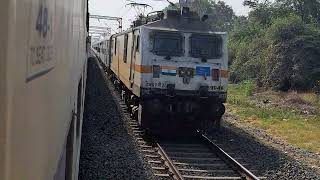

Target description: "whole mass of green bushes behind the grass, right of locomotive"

left=229, top=14, right=320, bottom=91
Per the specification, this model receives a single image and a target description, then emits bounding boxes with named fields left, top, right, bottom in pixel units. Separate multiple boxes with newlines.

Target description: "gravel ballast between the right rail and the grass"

left=208, top=115, right=320, bottom=180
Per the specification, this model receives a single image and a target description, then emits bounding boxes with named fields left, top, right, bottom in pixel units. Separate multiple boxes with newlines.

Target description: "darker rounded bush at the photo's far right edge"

left=264, top=15, right=320, bottom=90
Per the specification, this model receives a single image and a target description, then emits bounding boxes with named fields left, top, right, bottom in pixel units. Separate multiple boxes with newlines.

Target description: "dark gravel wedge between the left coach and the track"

left=79, top=59, right=153, bottom=180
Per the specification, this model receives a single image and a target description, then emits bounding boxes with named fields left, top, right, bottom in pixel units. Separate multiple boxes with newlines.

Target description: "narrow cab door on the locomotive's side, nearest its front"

left=130, top=30, right=140, bottom=88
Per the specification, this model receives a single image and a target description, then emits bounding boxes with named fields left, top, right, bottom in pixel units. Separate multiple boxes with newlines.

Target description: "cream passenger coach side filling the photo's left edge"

left=0, top=0, right=88, bottom=180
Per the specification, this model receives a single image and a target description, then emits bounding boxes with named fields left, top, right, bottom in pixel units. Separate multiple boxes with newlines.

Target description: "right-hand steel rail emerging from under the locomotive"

left=197, top=131, right=259, bottom=180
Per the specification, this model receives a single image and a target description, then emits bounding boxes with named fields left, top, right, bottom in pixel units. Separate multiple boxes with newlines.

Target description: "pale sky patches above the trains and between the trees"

left=89, top=0, right=249, bottom=33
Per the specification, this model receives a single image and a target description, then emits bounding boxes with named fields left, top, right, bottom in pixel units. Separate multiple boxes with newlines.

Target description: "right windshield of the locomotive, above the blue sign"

left=190, top=35, right=222, bottom=59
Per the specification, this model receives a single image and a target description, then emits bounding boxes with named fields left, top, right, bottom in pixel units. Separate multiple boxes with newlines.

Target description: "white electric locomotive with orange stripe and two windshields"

left=106, top=8, right=228, bottom=133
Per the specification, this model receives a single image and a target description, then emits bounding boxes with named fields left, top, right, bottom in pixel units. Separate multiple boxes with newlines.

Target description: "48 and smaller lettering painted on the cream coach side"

left=26, top=0, right=55, bottom=81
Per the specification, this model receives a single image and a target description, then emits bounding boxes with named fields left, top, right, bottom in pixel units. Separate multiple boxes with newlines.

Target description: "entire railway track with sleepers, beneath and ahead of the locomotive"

left=101, top=60, right=265, bottom=180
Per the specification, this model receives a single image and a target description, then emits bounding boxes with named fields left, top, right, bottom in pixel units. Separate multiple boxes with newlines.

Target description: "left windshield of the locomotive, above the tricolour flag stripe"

left=153, top=32, right=183, bottom=56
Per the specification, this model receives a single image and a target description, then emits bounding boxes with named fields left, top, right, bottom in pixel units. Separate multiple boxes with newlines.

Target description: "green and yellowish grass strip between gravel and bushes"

left=227, top=81, right=320, bottom=153
